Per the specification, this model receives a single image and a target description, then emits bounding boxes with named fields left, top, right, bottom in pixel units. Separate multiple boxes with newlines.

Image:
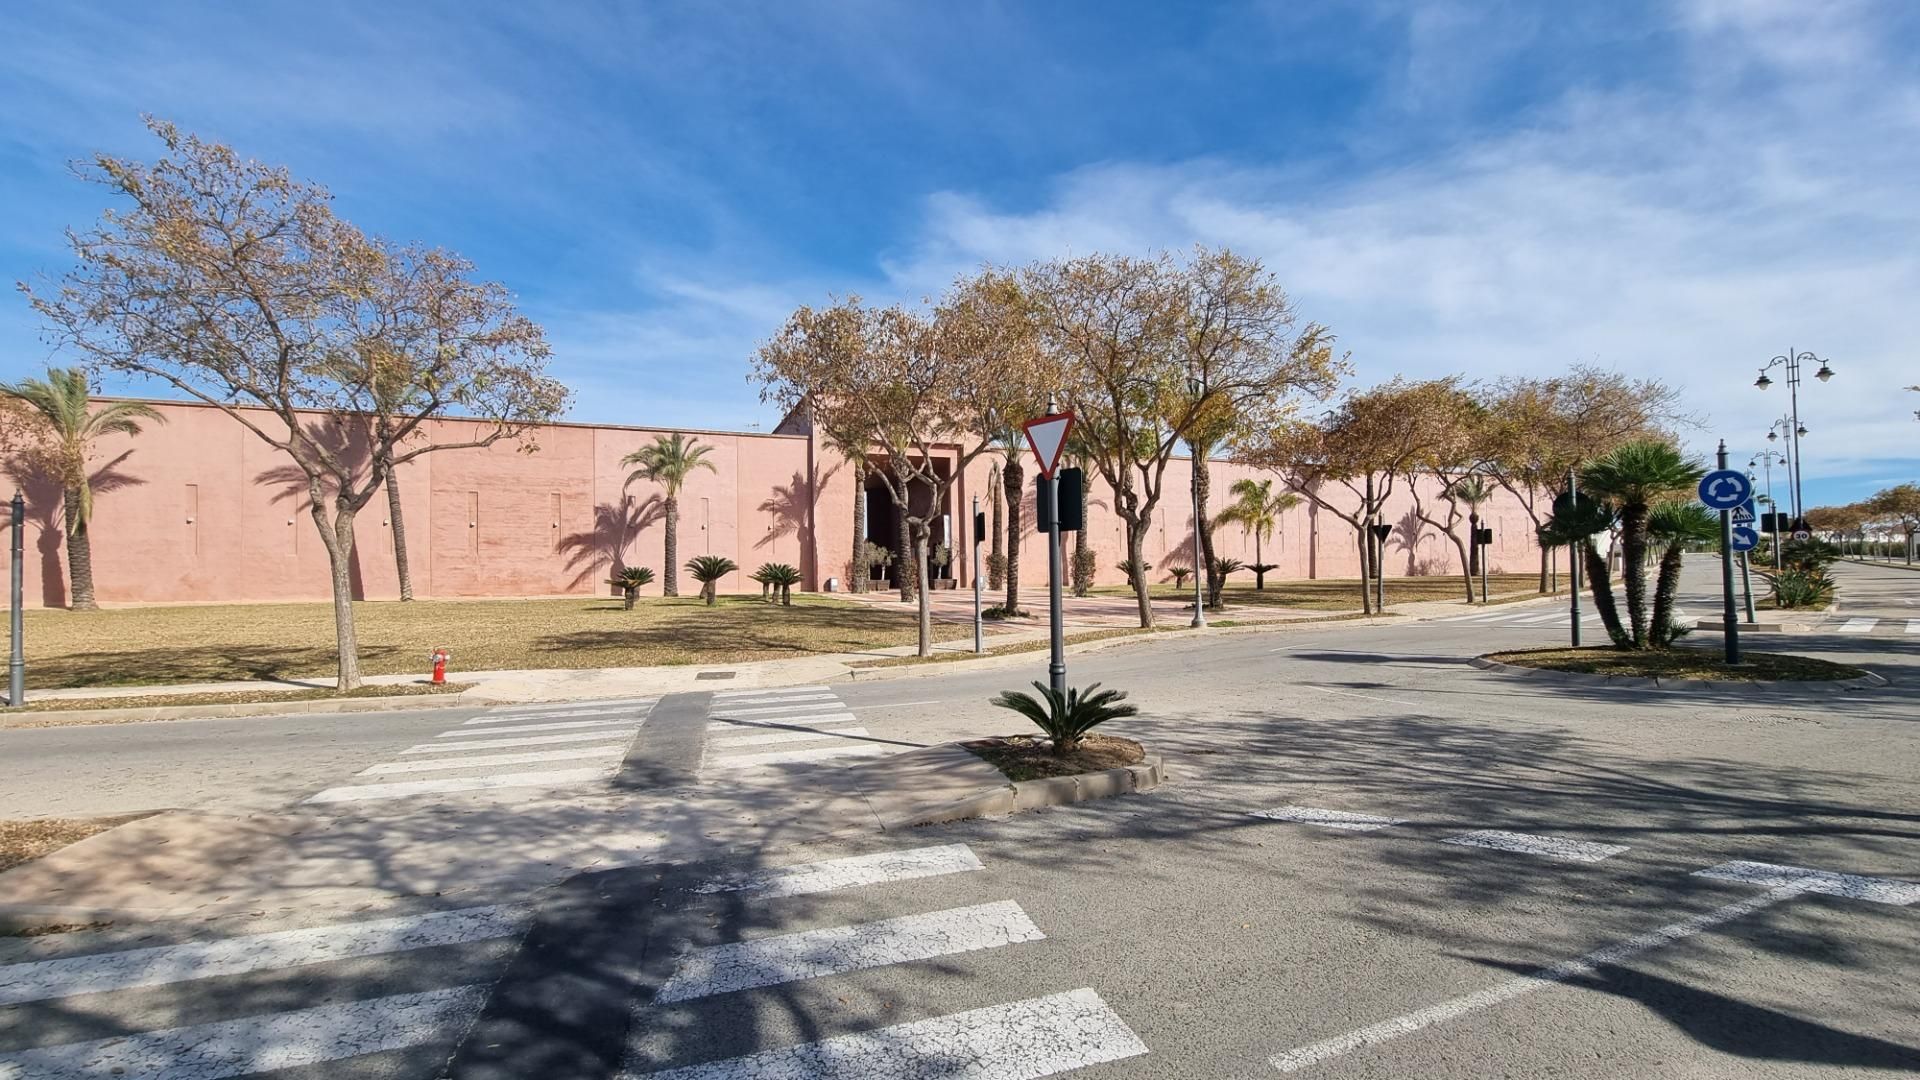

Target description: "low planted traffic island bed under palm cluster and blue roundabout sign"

left=1473, top=646, right=1887, bottom=690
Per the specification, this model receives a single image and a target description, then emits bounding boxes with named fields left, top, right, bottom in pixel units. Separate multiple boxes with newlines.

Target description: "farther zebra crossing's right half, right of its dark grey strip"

left=703, top=686, right=899, bottom=778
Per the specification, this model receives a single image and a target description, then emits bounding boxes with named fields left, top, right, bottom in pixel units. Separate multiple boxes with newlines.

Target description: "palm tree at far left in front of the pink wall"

left=0, top=367, right=167, bottom=611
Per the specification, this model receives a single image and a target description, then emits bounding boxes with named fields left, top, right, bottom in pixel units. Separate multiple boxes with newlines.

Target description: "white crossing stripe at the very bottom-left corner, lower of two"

left=0, top=986, right=486, bottom=1080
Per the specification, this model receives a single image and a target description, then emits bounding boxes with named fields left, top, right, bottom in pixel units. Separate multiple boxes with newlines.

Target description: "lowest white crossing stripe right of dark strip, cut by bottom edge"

left=620, top=990, right=1146, bottom=1080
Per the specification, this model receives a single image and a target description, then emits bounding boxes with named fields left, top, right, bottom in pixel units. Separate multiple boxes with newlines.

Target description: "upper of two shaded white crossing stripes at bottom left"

left=0, top=907, right=526, bottom=1005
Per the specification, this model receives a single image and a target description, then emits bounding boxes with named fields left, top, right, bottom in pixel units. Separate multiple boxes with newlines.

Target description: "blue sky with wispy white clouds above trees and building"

left=0, top=0, right=1920, bottom=502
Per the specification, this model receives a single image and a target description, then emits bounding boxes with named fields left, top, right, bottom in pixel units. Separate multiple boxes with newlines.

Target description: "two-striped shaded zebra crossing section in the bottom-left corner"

left=0, top=905, right=528, bottom=1080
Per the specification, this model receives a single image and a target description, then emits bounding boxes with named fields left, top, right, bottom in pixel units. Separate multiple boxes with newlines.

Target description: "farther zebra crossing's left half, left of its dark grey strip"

left=303, top=698, right=657, bottom=805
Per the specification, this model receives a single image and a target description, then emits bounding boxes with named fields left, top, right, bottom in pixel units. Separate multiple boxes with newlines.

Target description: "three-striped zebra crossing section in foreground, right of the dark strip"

left=620, top=844, right=1148, bottom=1080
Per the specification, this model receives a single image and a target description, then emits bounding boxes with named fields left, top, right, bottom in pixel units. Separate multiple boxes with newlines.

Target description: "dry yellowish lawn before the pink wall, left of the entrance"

left=0, top=596, right=973, bottom=690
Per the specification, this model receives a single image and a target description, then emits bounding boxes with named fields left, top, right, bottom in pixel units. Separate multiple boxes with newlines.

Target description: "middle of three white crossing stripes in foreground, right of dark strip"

left=653, top=899, right=1046, bottom=1005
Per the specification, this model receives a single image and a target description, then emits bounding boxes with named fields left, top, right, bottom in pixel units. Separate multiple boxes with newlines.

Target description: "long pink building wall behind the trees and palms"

left=15, top=402, right=1540, bottom=607
